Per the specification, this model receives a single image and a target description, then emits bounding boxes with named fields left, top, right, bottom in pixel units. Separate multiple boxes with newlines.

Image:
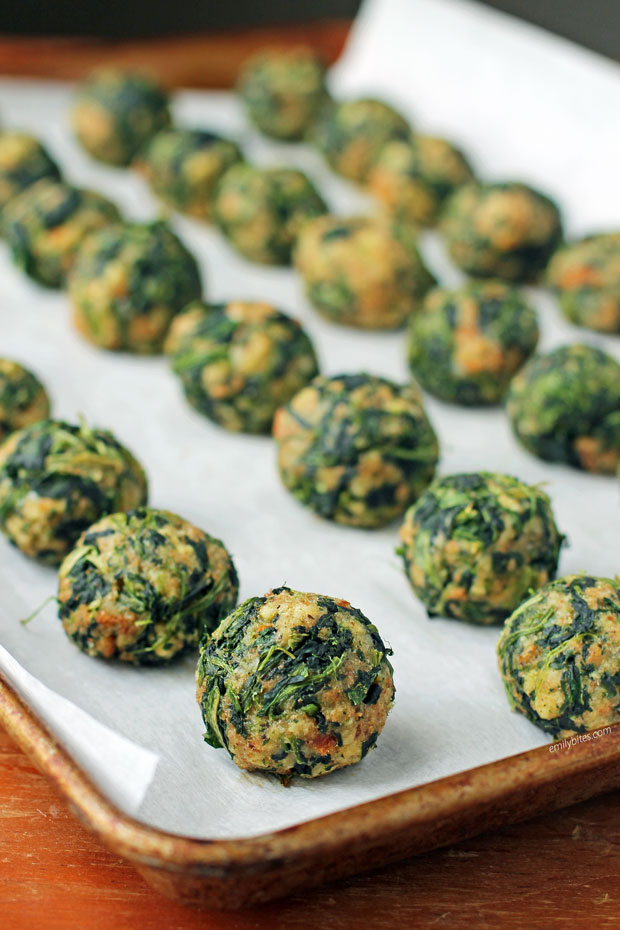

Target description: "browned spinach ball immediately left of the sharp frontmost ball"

left=58, top=507, right=239, bottom=665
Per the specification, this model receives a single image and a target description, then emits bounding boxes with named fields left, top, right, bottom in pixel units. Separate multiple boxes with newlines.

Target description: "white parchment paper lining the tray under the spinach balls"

left=0, top=0, right=620, bottom=838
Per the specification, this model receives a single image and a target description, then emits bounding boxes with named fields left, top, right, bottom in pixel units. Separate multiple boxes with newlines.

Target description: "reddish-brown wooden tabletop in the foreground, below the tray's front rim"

left=0, top=730, right=620, bottom=930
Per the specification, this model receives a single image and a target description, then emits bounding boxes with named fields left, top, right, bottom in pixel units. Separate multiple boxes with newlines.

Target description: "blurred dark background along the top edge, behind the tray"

left=0, top=0, right=620, bottom=59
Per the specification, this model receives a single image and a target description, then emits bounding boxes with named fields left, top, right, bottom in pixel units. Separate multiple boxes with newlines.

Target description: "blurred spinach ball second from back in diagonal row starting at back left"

left=135, top=128, right=242, bottom=220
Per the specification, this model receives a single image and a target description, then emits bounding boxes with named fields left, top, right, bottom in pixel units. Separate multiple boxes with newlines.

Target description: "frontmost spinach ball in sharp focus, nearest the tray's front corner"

left=196, top=587, right=394, bottom=779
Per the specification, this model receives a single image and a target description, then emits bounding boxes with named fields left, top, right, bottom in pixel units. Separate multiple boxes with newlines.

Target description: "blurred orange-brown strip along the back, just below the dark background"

left=0, top=19, right=351, bottom=88
